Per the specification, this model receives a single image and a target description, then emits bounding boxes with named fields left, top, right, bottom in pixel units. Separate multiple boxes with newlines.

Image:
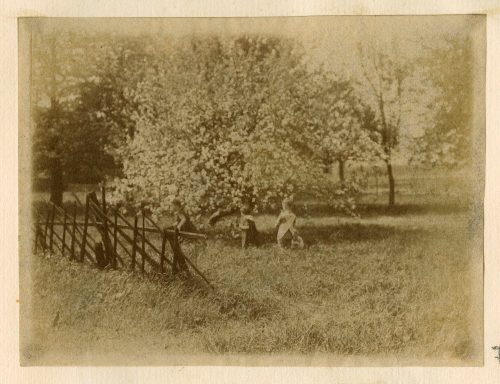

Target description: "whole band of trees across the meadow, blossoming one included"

left=32, top=32, right=473, bottom=212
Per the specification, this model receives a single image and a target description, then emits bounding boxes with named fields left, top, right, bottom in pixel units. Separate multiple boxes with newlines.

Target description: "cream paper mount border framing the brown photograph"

left=0, top=1, right=500, bottom=383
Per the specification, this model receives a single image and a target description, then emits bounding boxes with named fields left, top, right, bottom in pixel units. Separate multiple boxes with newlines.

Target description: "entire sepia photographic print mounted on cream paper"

left=18, top=15, right=486, bottom=367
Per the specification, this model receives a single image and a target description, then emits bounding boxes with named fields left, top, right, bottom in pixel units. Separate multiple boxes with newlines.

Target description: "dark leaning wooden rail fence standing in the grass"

left=35, top=188, right=212, bottom=287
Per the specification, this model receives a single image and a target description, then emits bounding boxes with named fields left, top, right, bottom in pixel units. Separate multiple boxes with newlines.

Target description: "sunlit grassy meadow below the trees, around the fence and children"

left=21, top=208, right=482, bottom=365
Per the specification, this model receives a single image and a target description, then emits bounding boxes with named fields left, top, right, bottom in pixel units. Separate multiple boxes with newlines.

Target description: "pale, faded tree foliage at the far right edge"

left=412, top=34, right=474, bottom=167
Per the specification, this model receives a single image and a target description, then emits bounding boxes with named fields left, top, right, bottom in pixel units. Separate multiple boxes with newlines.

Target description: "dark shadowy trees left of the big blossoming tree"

left=32, top=32, right=146, bottom=204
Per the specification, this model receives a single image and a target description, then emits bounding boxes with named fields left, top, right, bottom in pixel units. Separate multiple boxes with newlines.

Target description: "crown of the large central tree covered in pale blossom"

left=110, top=36, right=360, bottom=212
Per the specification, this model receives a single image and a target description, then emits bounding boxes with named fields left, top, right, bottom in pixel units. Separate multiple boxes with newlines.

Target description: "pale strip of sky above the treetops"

left=26, top=15, right=486, bottom=73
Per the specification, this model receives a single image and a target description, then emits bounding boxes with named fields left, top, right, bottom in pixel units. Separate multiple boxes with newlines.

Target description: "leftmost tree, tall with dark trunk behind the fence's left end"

left=32, top=34, right=87, bottom=204
